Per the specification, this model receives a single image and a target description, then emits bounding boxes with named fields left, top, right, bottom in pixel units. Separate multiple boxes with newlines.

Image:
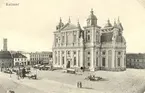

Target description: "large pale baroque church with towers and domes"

left=53, top=10, right=126, bottom=71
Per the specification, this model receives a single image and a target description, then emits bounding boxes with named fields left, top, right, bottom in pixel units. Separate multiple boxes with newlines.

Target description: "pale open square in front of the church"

left=0, top=69, right=145, bottom=93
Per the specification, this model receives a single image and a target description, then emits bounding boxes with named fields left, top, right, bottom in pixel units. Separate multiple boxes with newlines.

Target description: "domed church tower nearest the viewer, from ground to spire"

left=84, top=9, right=101, bottom=71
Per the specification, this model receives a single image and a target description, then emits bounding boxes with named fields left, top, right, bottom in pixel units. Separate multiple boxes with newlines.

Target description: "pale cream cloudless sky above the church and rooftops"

left=0, top=0, right=145, bottom=53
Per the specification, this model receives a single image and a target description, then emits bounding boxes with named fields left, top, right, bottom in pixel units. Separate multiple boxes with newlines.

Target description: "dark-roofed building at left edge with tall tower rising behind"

left=0, top=38, right=13, bottom=68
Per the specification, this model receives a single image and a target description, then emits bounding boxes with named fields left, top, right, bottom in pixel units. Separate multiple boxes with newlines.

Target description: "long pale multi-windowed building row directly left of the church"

left=30, top=51, right=52, bottom=65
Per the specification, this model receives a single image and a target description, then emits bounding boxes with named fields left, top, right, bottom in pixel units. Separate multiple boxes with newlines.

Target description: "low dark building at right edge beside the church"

left=126, top=53, right=145, bottom=68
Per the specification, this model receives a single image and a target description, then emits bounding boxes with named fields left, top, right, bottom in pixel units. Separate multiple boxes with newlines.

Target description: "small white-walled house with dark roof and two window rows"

left=12, top=53, right=28, bottom=66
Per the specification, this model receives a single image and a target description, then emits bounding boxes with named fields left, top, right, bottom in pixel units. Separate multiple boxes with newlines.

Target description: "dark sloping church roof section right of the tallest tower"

left=101, top=32, right=113, bottom=42
